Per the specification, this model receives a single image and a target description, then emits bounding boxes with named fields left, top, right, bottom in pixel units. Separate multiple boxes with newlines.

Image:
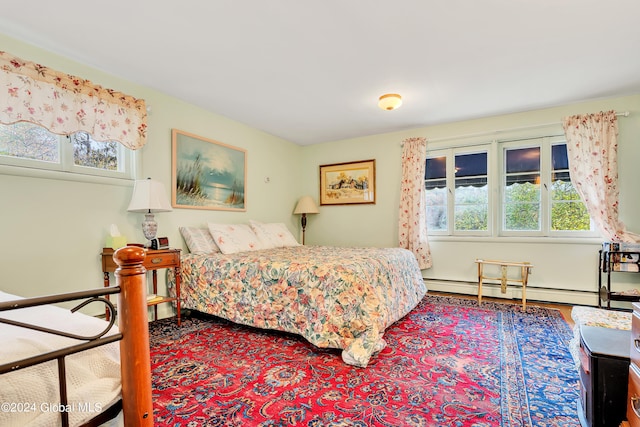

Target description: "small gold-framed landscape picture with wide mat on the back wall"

left=320, top=159, right=376, bottom=206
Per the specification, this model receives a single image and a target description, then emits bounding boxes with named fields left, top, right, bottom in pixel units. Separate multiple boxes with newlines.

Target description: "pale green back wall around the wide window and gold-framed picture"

left=302, top=95, right=640, bottom=305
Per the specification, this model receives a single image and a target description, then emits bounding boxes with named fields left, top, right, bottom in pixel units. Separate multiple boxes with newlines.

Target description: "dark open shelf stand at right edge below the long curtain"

left=598, top=249, right=640, bottom=308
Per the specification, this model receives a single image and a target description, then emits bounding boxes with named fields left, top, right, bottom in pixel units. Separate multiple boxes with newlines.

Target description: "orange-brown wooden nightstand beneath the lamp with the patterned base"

left=102, top=248, right=181, bottom=326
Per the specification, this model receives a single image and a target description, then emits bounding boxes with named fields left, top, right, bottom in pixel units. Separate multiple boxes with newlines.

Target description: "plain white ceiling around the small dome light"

left=0, top=0, right=640, bottom=145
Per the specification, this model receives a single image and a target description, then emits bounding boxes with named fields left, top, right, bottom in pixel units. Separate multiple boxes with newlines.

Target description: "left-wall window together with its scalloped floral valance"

left=0, top=51, right=147, bottom=182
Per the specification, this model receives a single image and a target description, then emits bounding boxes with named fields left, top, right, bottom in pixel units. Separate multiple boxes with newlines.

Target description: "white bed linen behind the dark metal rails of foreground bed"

left=0, top=291, right=121, bottom=426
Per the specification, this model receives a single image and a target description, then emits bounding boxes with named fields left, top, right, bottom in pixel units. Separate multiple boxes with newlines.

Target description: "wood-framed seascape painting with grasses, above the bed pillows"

left=171, top=129, right=247, bottom=212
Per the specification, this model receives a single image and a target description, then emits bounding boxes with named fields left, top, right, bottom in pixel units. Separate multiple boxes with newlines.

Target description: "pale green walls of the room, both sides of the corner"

left=0, top=31, right=640, bottom=310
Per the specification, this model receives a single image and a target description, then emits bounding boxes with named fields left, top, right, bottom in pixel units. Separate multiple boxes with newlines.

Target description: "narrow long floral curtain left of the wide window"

left=398, top=138, right=431, bottom=269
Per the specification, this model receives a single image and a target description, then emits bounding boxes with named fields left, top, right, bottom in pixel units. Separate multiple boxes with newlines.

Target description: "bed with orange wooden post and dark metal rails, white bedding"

left=0, top=247, right=153, bottom=426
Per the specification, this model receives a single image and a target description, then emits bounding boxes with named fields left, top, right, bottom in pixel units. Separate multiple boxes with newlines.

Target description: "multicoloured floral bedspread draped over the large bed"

left=167, top=246, right=427, bottom=367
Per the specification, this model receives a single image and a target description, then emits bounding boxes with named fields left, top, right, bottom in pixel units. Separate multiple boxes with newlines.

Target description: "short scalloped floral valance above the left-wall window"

left=0, top=51, right=147, bottom=150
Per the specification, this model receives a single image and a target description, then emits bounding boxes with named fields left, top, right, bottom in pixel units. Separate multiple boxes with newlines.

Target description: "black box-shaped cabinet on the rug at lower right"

left=578, top=326, right=631, bottom=427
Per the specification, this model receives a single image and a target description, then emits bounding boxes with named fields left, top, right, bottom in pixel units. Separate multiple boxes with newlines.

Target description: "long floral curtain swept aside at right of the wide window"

left=562, top=111, right=640, bottom=242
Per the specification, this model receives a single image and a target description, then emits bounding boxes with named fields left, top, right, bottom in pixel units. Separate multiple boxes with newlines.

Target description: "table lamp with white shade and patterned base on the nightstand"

left=127, top=178, right=172, bottom=247
